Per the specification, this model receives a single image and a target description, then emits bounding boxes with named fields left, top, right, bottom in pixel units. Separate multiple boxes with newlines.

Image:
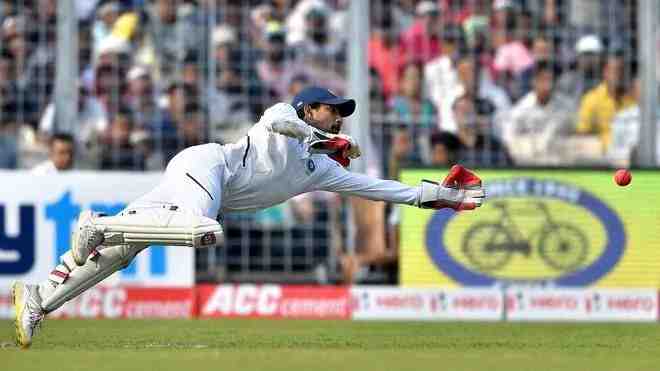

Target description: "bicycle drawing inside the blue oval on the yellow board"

left=461, top=201, right=589, bottom=273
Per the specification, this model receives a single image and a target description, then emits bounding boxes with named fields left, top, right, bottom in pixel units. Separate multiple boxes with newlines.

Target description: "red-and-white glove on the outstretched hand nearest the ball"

left=418, top=165, right=486, bottom=211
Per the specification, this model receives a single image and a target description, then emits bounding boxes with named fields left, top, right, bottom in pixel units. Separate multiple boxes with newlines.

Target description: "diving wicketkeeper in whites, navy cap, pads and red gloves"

left=12, top=87, right=484, bottom=347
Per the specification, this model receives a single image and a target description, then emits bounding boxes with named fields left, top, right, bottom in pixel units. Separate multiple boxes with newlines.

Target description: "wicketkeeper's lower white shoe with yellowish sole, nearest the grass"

left=11, top=281, right=45, bottom=349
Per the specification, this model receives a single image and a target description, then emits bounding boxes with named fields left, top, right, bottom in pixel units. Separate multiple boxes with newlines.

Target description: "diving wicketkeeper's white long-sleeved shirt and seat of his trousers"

left=144, top=103, right=420, bottom=218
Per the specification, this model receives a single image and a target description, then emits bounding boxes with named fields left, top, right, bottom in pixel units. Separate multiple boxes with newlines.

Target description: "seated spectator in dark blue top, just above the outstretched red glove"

left=453, top=95, right=513, bottom=166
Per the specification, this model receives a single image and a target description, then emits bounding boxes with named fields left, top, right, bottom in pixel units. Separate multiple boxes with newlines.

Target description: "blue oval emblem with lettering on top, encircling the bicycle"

left=425, top=177, right=626, bottom=287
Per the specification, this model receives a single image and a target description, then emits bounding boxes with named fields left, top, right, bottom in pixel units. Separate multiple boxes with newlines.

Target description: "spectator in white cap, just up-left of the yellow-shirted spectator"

left=558, top=35, right=603, bottom=100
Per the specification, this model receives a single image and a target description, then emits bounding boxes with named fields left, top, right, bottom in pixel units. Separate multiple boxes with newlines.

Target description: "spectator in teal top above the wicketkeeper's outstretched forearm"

left=391, top=63, right=437, bottom=164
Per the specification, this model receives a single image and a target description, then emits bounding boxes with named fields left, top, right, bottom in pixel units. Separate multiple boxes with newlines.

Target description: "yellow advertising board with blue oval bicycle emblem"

left=399, top=169, right=660, bottom=287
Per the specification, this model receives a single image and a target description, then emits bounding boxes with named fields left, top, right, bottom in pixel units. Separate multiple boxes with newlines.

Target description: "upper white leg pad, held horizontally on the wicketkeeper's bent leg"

left=92, top=208, right=222, bottom=247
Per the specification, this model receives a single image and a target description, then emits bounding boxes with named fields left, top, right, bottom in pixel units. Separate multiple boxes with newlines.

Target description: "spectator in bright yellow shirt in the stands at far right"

left=576, top=55, right=635, bottom=150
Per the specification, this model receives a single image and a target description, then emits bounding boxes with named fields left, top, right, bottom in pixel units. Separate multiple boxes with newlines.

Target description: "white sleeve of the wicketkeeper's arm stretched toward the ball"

left=318, top=160, right=420, bottom=206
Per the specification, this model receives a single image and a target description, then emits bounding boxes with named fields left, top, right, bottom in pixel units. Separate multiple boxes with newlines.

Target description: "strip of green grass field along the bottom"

left=0, top=320, right=660, bottom=371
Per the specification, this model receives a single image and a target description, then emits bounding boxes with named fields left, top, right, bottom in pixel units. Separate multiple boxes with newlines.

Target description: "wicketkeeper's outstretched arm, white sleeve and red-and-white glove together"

left=319, top=166, right=485, bottom=210
